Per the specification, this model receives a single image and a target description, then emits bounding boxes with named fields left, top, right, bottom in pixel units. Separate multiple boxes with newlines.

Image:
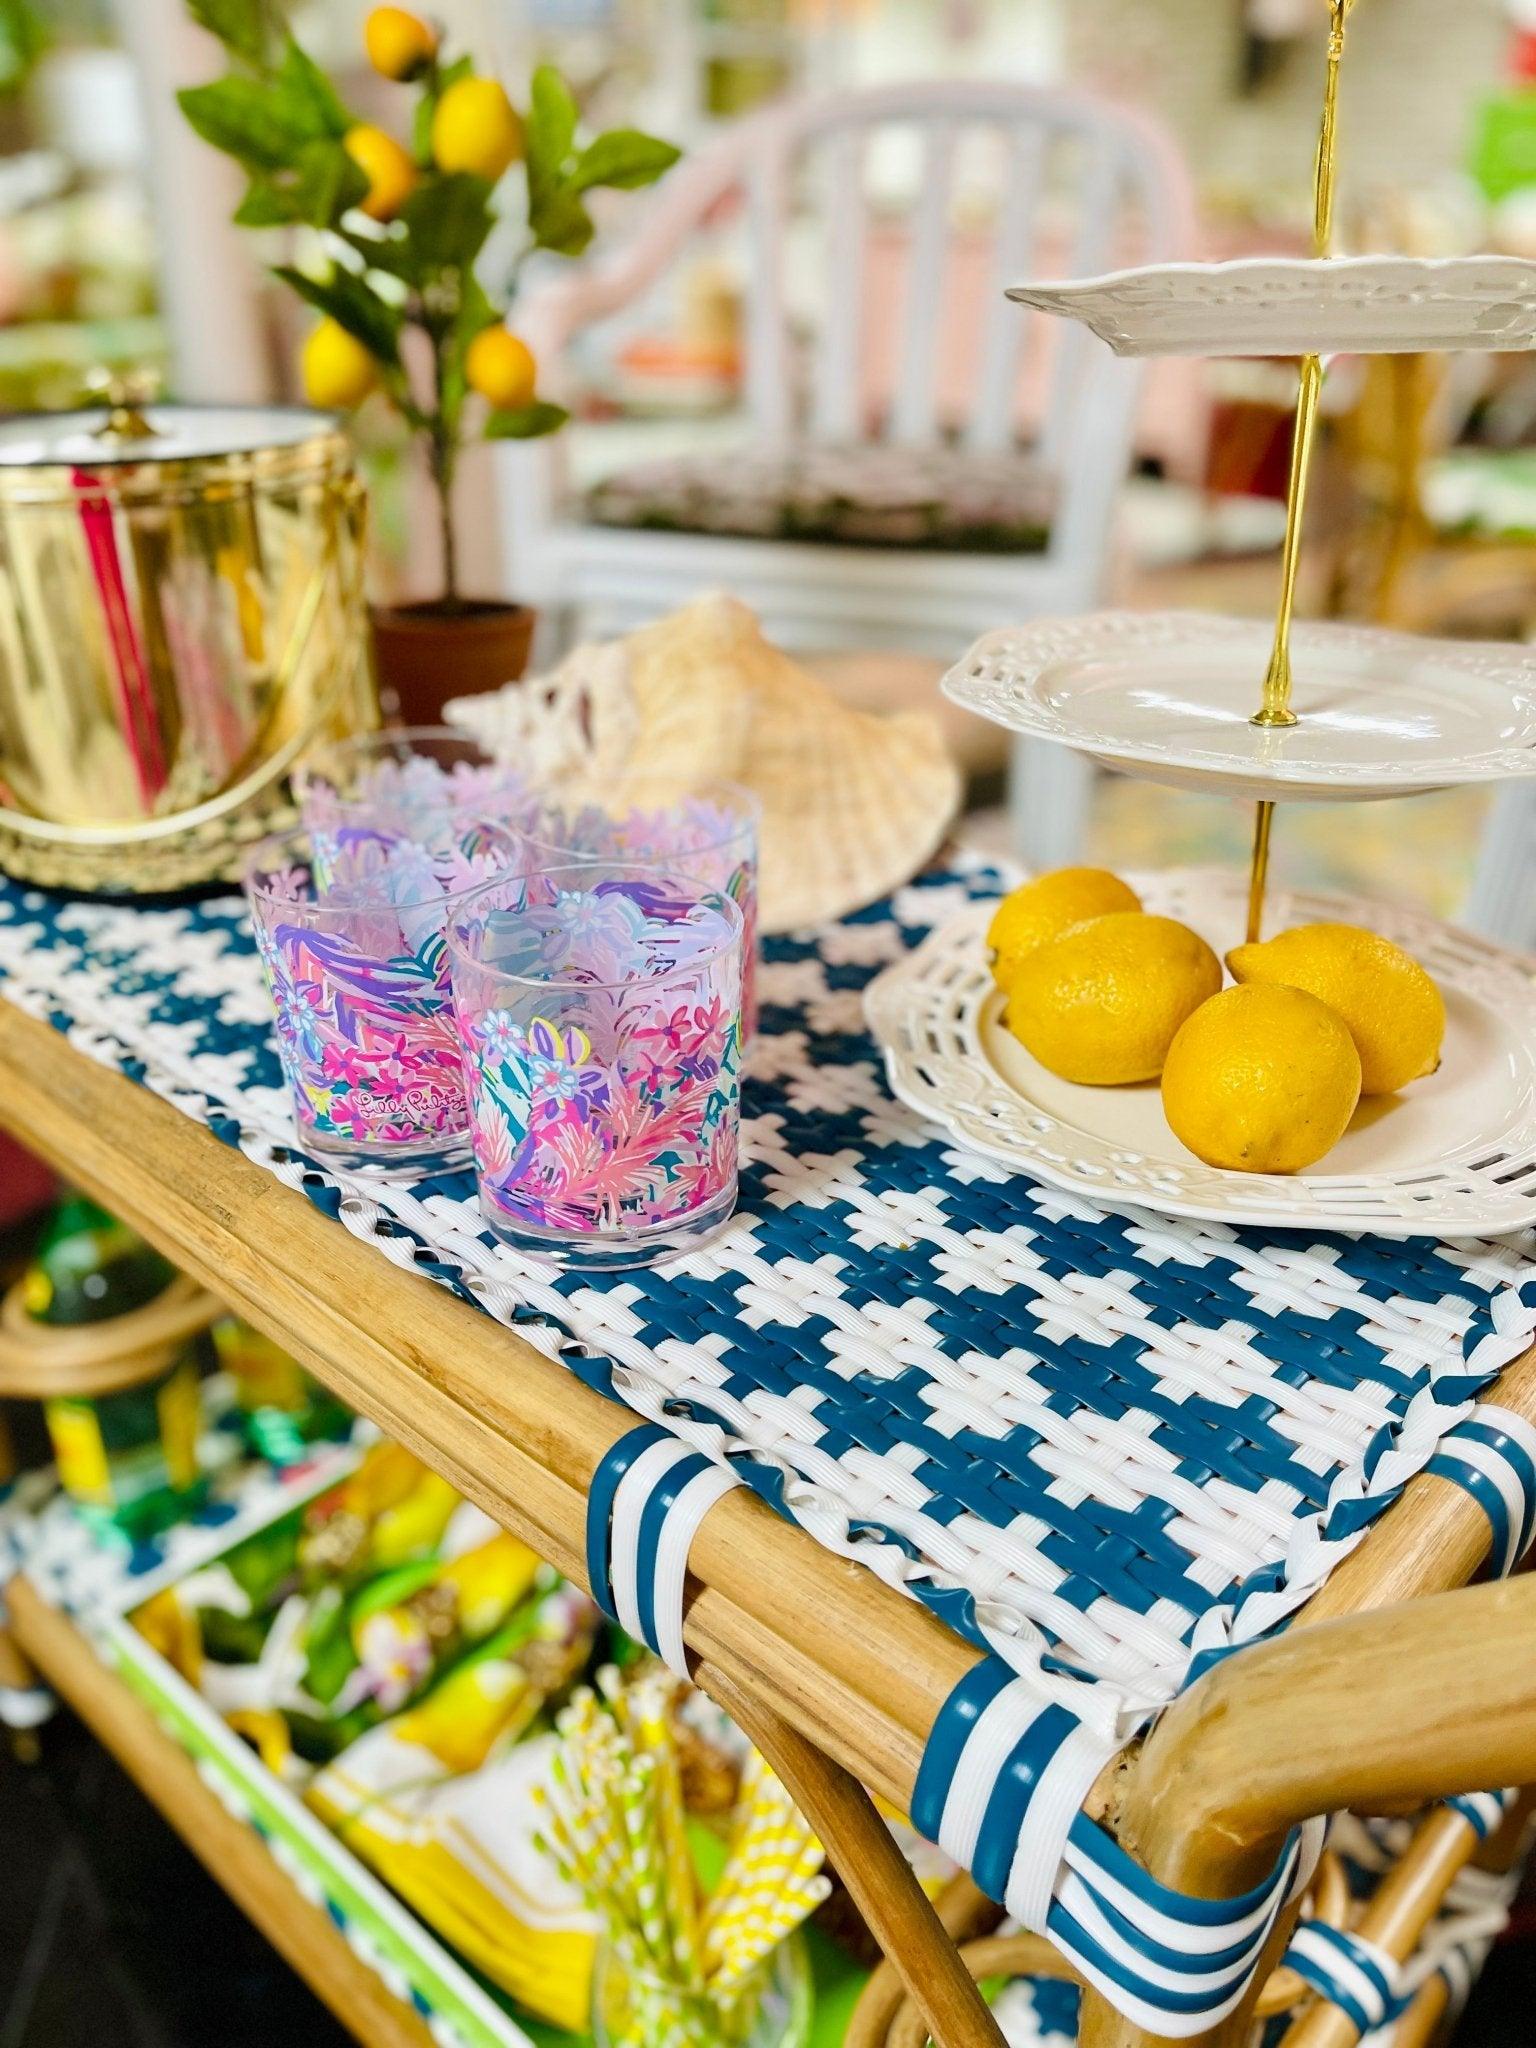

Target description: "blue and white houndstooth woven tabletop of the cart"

left=0, top=864, right=1536, bottom=1733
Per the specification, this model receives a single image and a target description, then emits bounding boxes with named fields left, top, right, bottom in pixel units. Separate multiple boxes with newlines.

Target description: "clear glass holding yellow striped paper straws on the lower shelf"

left=592, top=1935, right=811, bottom=2048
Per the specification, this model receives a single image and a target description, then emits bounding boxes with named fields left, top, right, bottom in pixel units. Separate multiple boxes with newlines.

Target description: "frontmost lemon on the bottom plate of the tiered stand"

left=1163, top=985, right=1360, bottom=1174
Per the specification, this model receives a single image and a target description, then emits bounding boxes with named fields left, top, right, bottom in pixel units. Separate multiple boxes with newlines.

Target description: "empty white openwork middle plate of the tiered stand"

left=944, top=612, right=1536, bottom=803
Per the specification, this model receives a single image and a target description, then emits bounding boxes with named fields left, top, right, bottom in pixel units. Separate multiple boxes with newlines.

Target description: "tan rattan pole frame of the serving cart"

left=0, top=1004, right=1536, bottom=2048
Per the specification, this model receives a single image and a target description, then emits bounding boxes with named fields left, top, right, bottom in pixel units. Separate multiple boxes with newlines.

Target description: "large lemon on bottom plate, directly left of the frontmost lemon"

left=1008, top=909, right=1221, bottom=1087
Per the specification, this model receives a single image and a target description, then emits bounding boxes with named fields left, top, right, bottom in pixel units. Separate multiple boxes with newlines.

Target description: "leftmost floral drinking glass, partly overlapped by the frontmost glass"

left=246, top=821, right=522, bottom=1161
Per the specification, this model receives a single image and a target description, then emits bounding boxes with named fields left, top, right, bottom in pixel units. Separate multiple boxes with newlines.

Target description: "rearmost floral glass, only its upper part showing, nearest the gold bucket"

left=293, top=725, right=532, bottom=866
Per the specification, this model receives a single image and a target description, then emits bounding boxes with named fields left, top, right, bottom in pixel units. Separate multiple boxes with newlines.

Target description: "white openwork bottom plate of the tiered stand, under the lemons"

left=864, top=868, right=1536, bottom=1237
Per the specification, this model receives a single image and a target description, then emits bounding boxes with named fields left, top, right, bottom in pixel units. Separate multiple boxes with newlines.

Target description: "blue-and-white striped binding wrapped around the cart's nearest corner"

left=911, top=1657, right=1323, bottom=2038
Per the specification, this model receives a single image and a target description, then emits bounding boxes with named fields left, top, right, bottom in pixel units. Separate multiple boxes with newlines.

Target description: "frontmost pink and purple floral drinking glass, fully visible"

left=449, top=860, right=743, bottom=1268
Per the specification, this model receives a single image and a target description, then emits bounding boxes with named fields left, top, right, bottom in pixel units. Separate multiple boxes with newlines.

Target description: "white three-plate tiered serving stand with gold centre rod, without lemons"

left=868, top=0, right=1536, bottom=1237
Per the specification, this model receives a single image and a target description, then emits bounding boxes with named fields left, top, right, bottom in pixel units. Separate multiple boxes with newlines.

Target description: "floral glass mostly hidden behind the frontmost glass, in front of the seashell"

left=528, top=782, right=762, bottom=1044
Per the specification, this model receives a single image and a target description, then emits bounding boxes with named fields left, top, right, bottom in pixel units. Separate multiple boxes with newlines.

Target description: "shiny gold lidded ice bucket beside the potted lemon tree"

left=0, top=406, right=377, bottom=893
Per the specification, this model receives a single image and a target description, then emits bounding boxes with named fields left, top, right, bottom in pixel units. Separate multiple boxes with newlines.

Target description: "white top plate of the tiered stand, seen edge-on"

left=1008, top=256, right=1536, bottom=356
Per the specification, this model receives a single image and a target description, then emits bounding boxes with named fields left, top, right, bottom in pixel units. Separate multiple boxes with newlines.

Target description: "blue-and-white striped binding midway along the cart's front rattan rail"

left=586, top=1421, right=741, bottom=1677
